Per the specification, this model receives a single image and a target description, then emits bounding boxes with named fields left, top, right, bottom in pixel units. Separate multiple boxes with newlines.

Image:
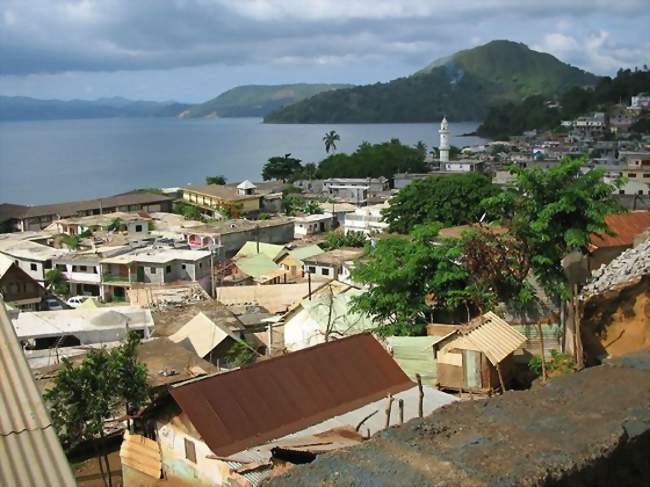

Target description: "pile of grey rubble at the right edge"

left=581, top=238, right=650, bottom=301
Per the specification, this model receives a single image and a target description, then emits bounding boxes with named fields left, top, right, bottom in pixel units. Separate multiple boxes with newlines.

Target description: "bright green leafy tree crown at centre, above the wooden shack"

left=352, top=224, right=485, bottom=335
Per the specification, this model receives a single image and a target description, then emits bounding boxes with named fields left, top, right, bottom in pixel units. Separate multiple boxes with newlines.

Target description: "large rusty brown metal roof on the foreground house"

left=170, top=334, right=413, bottom=456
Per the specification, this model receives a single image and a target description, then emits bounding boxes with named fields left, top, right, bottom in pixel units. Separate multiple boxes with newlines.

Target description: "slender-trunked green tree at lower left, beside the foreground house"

left=43, top=333, right=148, bottom=486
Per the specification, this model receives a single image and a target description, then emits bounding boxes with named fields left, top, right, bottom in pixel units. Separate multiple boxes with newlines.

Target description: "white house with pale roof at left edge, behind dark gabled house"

left=0, top=233, right=68, bottom=285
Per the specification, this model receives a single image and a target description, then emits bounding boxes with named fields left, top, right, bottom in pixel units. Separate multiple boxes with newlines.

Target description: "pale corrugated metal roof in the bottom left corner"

left=0, top=300, right=76, bottom=487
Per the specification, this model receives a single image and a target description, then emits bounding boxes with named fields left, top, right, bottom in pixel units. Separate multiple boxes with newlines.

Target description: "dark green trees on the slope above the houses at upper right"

left=477, top=69, right=650, bottom=138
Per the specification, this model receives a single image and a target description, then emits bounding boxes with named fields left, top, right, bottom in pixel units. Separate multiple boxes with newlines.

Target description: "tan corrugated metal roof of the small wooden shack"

left=449, top=311, right=526, bottom=365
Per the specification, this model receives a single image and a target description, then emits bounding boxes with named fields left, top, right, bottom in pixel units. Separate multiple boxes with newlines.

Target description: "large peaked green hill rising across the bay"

left=264, top=41, right=598, bottom=123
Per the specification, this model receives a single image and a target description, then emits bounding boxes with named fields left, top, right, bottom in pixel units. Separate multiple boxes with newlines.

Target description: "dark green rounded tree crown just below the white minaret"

left=383, top=173, right=497, bottom=233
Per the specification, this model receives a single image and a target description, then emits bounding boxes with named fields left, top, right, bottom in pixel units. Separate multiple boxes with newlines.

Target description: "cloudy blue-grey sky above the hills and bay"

left=0, top=0, right=650, bottom=102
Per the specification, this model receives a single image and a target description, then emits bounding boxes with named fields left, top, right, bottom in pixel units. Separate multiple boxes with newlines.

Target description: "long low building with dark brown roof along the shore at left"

left=0, top=191, right=173, bottom=232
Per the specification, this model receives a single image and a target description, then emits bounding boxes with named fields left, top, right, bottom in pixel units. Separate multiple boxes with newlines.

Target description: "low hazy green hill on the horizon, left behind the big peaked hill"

left=180, top=83, right=351, bottom=118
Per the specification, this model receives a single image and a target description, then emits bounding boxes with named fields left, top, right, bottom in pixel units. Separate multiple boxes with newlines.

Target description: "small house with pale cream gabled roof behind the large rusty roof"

left=169, top=312, right=257, bottom=368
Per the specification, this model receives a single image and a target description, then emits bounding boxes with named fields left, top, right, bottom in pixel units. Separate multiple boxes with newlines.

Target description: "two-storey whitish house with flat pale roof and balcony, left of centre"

left=100, top=247, right=212, bottom=301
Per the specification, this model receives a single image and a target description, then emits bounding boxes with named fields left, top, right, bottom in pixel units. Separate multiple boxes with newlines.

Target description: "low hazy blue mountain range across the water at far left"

left=0, top=96, right=189, bottom=121
